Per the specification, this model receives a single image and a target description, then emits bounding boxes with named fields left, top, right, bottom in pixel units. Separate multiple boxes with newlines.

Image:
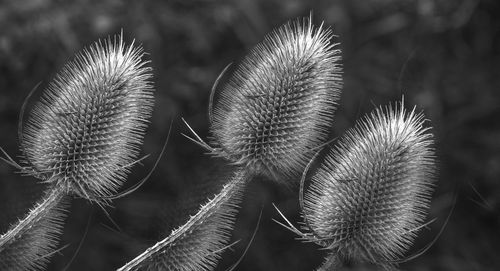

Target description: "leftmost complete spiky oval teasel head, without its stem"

left=21, top=36, right=154, bottom=200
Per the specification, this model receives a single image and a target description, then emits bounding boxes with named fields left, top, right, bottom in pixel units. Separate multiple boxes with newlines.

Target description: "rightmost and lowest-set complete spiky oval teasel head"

left=303, top=103, right=435, bottom=265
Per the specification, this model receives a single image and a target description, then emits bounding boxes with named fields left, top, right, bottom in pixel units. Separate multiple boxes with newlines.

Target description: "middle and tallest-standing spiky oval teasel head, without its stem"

left=211, top=19, right=342, bottom=183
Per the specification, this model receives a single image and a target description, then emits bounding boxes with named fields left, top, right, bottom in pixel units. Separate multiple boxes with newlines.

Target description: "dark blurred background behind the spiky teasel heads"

left=0, top=0, right=500, bottom=270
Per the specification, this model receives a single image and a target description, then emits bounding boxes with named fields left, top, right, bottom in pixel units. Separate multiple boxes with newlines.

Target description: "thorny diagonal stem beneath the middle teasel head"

left=118, top=169, right=250, bottom=271
